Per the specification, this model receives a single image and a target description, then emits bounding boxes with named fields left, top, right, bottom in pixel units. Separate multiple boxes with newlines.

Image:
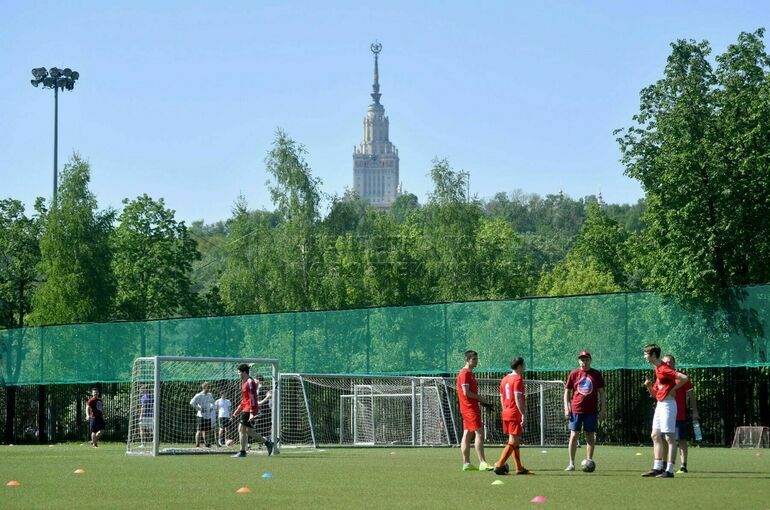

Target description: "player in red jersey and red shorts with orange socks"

left=494, top=357, right=529, bottom=475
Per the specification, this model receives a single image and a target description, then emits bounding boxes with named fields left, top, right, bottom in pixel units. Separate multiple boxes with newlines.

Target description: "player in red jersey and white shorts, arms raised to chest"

left=642, top=344, right=689, bottom=478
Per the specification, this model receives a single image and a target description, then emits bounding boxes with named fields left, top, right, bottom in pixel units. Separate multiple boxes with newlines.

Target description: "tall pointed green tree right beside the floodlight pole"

left=29, top=154, right=115, bottom=325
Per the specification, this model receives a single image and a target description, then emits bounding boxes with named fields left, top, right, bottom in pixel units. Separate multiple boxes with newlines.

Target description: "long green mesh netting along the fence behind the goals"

left=0, top=286, right=770, bottom=385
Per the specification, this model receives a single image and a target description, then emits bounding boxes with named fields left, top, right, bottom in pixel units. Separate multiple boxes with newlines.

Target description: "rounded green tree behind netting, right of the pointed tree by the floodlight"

left=111, top=194, right=201, bottom=320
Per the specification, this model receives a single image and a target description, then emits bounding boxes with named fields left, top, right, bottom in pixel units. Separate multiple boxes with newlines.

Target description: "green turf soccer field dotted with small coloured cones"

left=0, top=443, right=770, bottom=510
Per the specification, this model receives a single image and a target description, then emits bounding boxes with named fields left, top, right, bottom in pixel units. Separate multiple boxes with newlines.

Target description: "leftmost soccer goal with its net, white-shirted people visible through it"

left=126, top=356, right=281, bottom=455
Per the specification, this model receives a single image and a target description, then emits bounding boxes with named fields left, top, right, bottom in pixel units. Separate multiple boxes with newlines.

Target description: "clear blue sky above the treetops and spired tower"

left=0, top=0, right=770, bottom=223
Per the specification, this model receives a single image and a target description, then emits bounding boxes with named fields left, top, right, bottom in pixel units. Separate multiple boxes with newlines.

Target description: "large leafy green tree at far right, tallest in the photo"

left=618, top=30, right=770, bottom=304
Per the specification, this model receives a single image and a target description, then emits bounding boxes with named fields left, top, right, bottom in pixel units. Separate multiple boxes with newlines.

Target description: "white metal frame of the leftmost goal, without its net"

left=126, top=356, right=281, bottom=456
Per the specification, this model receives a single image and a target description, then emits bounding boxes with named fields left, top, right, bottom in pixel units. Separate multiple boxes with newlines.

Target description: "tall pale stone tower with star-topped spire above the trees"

left=353, top=42, right=399, bottom=209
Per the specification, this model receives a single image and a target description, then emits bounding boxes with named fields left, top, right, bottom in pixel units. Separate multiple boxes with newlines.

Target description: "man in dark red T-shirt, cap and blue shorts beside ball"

left=564, top=351, right=607, bottom=471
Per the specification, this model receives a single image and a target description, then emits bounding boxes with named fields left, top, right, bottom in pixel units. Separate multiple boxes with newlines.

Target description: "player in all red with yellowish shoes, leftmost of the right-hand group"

left=457, top=351, right=492, bottom=471
